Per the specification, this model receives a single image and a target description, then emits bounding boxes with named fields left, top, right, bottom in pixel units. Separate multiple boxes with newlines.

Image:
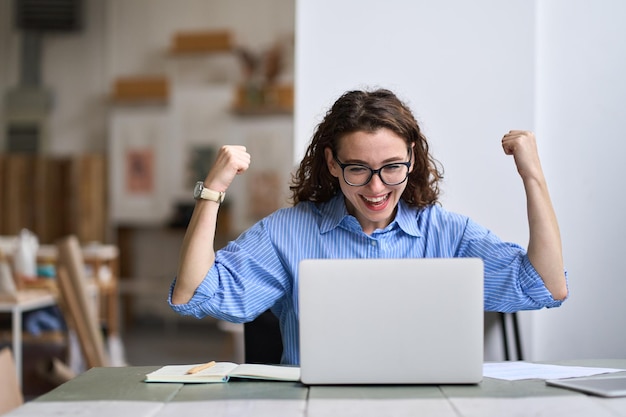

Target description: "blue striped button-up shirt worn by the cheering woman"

left=169, top=194, right=561, bottom=364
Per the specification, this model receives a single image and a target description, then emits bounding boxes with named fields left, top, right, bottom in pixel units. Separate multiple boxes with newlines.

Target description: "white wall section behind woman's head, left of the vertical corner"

left=294, top=0, right=534, bottom=241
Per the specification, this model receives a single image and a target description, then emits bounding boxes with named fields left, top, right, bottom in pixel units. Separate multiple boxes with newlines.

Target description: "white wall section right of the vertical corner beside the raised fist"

left=534, top=0, right=626, bottom=358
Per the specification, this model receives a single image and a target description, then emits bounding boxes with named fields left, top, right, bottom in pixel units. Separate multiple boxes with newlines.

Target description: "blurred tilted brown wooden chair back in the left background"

left=56, top=235, right=109, bottom=368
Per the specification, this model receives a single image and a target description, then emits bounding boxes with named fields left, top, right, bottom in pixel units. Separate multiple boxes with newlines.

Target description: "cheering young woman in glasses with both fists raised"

left=169, top=90, right=567, bottom=364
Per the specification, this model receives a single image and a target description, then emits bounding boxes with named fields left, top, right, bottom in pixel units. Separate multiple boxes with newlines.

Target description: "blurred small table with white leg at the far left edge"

left=0, top=290, right=56, bottom=387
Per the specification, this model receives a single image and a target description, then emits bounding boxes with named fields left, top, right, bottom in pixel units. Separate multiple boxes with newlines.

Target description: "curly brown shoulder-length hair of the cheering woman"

left=289, top=89, right=443, bottom=208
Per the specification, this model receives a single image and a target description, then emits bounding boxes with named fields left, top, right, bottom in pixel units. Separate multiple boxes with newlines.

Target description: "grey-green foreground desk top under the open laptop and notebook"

left=8, top=359, right=626, bottom=417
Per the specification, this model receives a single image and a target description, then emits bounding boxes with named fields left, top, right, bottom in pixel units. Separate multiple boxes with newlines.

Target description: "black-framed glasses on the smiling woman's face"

left=333, top=149, right=412, bottom=187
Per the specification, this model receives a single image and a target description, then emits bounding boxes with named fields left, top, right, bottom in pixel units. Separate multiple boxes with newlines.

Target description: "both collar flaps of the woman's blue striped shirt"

left=319, top=193, right=421, bottom=237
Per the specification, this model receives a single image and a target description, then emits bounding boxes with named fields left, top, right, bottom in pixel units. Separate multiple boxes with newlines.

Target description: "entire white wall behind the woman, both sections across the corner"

left=294, top=0, right=626, bottom=360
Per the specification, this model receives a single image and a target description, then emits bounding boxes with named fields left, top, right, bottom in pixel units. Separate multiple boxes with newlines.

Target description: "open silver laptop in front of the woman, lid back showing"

left=298, top=258, right=484, bottom=385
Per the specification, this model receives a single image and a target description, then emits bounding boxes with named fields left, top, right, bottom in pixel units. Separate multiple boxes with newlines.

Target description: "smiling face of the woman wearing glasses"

left=325, top=128, right=413, bottom=235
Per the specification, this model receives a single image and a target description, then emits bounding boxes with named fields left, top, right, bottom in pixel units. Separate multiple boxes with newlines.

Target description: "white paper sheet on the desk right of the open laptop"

left=483, top=361, right=626, bottom=381
